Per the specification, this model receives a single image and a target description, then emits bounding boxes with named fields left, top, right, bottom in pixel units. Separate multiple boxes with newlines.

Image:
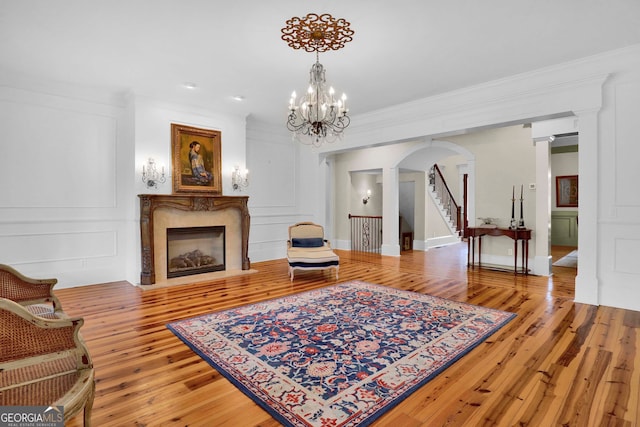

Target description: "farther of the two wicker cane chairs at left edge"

left=0, top=264, right=68, bottom=319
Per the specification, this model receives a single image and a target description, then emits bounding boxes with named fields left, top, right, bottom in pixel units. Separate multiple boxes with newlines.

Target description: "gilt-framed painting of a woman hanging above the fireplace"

left=171, top=123, right=222, bottom=194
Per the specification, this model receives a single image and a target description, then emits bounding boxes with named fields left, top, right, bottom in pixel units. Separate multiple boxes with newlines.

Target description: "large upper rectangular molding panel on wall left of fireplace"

left=0, top=92, right=117, bottom=208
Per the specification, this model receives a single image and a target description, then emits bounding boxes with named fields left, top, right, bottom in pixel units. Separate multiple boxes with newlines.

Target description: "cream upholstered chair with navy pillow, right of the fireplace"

left=287, top=222, right=340, bottom=282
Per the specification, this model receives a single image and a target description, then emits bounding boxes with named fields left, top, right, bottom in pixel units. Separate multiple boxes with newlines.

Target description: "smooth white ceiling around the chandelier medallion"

left=0, top=0, right=640, bottom=126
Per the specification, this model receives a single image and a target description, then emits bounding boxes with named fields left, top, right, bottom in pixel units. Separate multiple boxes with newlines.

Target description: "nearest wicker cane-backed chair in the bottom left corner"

left=0, top=298, right=95, bottom=426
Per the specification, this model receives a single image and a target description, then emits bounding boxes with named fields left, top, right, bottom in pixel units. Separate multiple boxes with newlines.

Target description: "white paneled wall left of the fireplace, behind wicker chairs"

left=0, top=81, right=137, bottom=288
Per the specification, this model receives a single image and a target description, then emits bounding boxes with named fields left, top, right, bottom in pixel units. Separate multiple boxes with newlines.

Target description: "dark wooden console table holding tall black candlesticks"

left=467, top=227, right=531, bottom=274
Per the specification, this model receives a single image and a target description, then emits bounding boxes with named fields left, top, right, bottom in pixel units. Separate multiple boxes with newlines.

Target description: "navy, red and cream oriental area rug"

left=167, top=281, right=515, bottom=427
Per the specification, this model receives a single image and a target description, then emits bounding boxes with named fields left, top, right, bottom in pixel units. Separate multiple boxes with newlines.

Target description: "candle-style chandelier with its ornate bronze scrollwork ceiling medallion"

left=281, top=13, right=354, bottom=147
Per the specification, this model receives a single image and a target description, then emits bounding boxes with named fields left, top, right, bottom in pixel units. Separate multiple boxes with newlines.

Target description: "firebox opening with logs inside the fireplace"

left=167, top=225, right=225, bottom=279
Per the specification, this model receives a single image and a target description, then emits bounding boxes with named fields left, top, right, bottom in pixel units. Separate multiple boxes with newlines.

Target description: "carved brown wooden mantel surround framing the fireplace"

left=138, top=194, right=251, bottom=285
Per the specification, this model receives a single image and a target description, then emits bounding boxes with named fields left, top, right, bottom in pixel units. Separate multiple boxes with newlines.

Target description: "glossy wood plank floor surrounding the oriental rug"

left=57, top=243, right=640, bottom=427
